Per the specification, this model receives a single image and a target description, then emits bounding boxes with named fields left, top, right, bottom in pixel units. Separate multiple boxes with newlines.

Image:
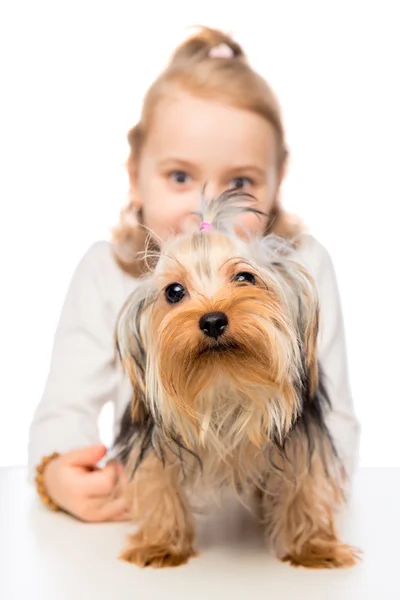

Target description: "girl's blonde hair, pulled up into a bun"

left=112, top=27, right=301, bottom=275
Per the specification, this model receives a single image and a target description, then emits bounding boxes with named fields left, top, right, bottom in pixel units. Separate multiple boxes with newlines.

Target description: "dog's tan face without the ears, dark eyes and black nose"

left=150, top=232, right=294, bottom=404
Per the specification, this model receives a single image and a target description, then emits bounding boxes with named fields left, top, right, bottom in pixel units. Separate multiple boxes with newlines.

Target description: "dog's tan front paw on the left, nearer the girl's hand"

left=119, top=545, right=197, bottom=569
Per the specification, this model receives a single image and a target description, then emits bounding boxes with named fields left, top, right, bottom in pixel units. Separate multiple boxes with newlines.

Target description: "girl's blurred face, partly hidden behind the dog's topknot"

left=131, top=92, right=279, bottom=241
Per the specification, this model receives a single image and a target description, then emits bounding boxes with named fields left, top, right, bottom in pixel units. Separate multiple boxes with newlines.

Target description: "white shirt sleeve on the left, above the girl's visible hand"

left=28, top=242, right=118, bottom=479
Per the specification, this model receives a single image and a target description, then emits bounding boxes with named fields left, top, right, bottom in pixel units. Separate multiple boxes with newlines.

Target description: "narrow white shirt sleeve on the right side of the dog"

left=310, top=238, right=360, bottom=491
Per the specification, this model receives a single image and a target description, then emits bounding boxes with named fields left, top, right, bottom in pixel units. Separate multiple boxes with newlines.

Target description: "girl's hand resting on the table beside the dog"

left=44, top=446, right=129, bottom=522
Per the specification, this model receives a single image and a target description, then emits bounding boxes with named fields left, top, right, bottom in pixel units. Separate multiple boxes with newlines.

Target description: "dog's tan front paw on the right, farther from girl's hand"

left=282, top=543, right=362, bottom=569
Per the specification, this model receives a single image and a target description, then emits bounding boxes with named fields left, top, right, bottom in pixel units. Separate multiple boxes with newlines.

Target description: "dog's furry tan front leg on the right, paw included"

left=262, top=436, right=360, bottom=569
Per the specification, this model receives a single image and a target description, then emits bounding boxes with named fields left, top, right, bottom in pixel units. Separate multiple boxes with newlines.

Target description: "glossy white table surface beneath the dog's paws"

left=0, top=468, right=400, bottom=600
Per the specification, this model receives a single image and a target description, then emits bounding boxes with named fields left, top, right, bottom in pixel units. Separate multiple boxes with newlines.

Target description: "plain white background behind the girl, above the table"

left=0, top=0, right=400, bottom=466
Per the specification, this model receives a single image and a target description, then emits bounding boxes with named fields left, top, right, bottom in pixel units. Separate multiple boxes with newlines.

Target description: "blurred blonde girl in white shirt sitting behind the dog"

left=29, top=29, right=359, bottom=521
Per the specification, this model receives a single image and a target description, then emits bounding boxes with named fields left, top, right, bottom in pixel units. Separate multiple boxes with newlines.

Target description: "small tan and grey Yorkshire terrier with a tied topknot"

left=115, top=190, right=358, bottom=568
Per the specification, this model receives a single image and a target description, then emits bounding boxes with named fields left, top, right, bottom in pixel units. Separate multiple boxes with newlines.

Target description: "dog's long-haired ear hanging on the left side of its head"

left=115, top=280, right=154, bottom=421
